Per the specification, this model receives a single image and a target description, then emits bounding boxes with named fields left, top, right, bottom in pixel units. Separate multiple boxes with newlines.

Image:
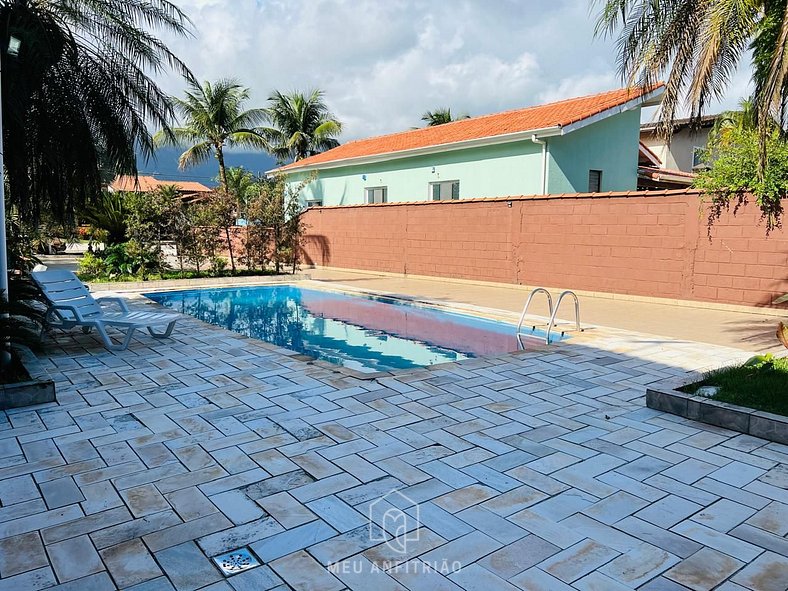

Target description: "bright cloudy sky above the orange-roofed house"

left=162, top=0, right=747, bottom=141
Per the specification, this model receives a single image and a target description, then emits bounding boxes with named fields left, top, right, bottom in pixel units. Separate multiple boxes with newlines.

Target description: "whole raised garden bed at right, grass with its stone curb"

left=646, top=356, right=788, bottom=444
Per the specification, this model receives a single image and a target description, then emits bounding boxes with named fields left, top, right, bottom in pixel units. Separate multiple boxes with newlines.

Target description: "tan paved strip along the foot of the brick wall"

left=306, top=269, right=788, bottom=352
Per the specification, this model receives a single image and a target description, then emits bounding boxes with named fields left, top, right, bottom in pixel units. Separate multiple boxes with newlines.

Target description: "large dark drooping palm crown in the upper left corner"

left=0, top=0, right=191, bottom=227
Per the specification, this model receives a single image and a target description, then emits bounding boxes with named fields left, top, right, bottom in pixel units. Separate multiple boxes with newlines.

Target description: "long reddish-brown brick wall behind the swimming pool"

left=304, top=191, right=788, bottom=306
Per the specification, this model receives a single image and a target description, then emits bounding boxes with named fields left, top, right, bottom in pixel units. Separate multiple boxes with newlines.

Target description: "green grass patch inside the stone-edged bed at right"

left=681, top=355, right=788, bottom=416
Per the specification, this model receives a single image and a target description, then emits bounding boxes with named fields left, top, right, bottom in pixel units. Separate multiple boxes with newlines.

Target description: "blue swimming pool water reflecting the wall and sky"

left=146, top=285, right=548, bottom=372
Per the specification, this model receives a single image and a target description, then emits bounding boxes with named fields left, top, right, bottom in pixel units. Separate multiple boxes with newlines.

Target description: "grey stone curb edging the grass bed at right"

left=646, top=378, right=788, bottom=445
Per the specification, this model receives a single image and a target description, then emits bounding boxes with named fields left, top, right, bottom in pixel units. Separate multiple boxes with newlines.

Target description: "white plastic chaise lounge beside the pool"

left=31, top=269, right=179, bottom=351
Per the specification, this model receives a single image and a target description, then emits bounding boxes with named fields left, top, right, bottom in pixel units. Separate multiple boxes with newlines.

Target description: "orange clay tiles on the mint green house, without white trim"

left=279, top=85, right=662, bottom=171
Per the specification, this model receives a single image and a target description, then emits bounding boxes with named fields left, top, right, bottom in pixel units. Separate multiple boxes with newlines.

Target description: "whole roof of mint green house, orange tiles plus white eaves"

left=278, top=84, right=663, bottom=172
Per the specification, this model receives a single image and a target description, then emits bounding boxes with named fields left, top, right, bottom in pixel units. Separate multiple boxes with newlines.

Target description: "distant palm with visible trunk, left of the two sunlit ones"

left=154, top=79, right=267, bottom=191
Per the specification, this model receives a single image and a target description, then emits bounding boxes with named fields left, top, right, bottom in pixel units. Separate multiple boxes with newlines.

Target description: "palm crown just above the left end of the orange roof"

left=265, top=90, right=342, bottom=162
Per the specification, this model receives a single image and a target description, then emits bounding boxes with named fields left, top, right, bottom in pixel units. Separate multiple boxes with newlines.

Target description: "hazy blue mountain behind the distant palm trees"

left=138, top=148, right=276, bottom=187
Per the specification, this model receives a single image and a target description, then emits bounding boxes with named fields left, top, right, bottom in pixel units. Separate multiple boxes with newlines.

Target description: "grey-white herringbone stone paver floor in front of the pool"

left=0, top=292, right=788, bottom=591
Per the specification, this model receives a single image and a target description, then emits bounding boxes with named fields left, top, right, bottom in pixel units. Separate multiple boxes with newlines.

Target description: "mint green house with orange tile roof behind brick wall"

left=271, top=87, right=663, bottom=206
